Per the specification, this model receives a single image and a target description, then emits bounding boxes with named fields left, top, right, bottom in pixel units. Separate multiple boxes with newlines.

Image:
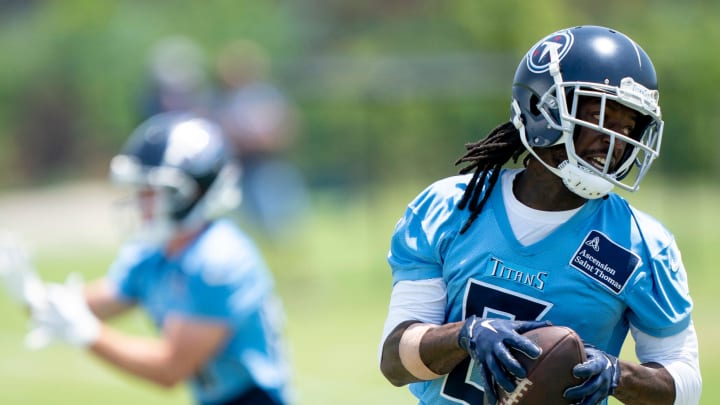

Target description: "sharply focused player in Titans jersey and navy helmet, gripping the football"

left=380, top=26, right=702, bottom=405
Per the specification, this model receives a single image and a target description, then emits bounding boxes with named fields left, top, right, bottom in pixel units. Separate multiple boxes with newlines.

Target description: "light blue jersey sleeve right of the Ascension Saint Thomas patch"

left=628, top=215, right=693, bottom=337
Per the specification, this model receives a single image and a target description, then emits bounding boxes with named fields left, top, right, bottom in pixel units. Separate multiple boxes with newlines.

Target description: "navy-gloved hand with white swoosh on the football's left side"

left=458, top=315, right=550, bottom=405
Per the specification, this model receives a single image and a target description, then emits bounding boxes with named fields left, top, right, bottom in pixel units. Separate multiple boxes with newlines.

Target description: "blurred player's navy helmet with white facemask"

left=110, top=112, right=240, bottom=244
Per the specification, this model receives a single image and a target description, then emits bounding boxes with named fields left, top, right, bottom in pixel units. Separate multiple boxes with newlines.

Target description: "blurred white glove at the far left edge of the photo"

left=0, top=232, right=45, bottom=306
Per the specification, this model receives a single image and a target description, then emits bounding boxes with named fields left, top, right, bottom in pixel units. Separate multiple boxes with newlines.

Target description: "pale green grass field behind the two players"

left=0, top=181, right=720, bottom=405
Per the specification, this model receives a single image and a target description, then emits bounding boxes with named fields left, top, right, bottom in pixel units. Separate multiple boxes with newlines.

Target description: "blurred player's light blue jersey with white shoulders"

left=109, top=220, right=289, bottom=404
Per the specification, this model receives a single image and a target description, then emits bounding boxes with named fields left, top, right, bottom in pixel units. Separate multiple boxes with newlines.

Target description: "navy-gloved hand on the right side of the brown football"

left=565, top=345, right=620, bottom=405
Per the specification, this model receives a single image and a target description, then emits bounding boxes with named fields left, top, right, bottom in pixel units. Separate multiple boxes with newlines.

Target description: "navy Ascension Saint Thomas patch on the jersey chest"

left=570, top=230, right=640, bottom=294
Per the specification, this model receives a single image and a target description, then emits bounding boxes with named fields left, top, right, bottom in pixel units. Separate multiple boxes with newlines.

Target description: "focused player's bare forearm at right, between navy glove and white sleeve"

left=614, top=360, right=675, bottom=405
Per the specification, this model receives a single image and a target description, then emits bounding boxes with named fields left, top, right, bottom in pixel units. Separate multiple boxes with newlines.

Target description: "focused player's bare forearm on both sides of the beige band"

left=380, top=321, right=467, bottom=386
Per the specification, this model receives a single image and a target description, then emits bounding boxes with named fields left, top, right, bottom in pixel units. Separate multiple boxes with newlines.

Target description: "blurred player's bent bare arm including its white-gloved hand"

left=26, top=277, right=230, bottom=387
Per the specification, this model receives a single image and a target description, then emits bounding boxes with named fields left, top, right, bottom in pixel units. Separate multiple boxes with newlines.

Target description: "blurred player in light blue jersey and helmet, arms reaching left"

left=27, top=113, right=290, bottom=405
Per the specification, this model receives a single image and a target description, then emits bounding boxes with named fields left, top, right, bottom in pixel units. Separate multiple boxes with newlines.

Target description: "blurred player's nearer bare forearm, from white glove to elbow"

left=89, top=325, right=192, bottom=387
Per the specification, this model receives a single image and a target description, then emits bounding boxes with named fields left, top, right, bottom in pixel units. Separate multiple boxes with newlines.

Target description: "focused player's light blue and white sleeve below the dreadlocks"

left=388, top=176, right=465, bottom=285
